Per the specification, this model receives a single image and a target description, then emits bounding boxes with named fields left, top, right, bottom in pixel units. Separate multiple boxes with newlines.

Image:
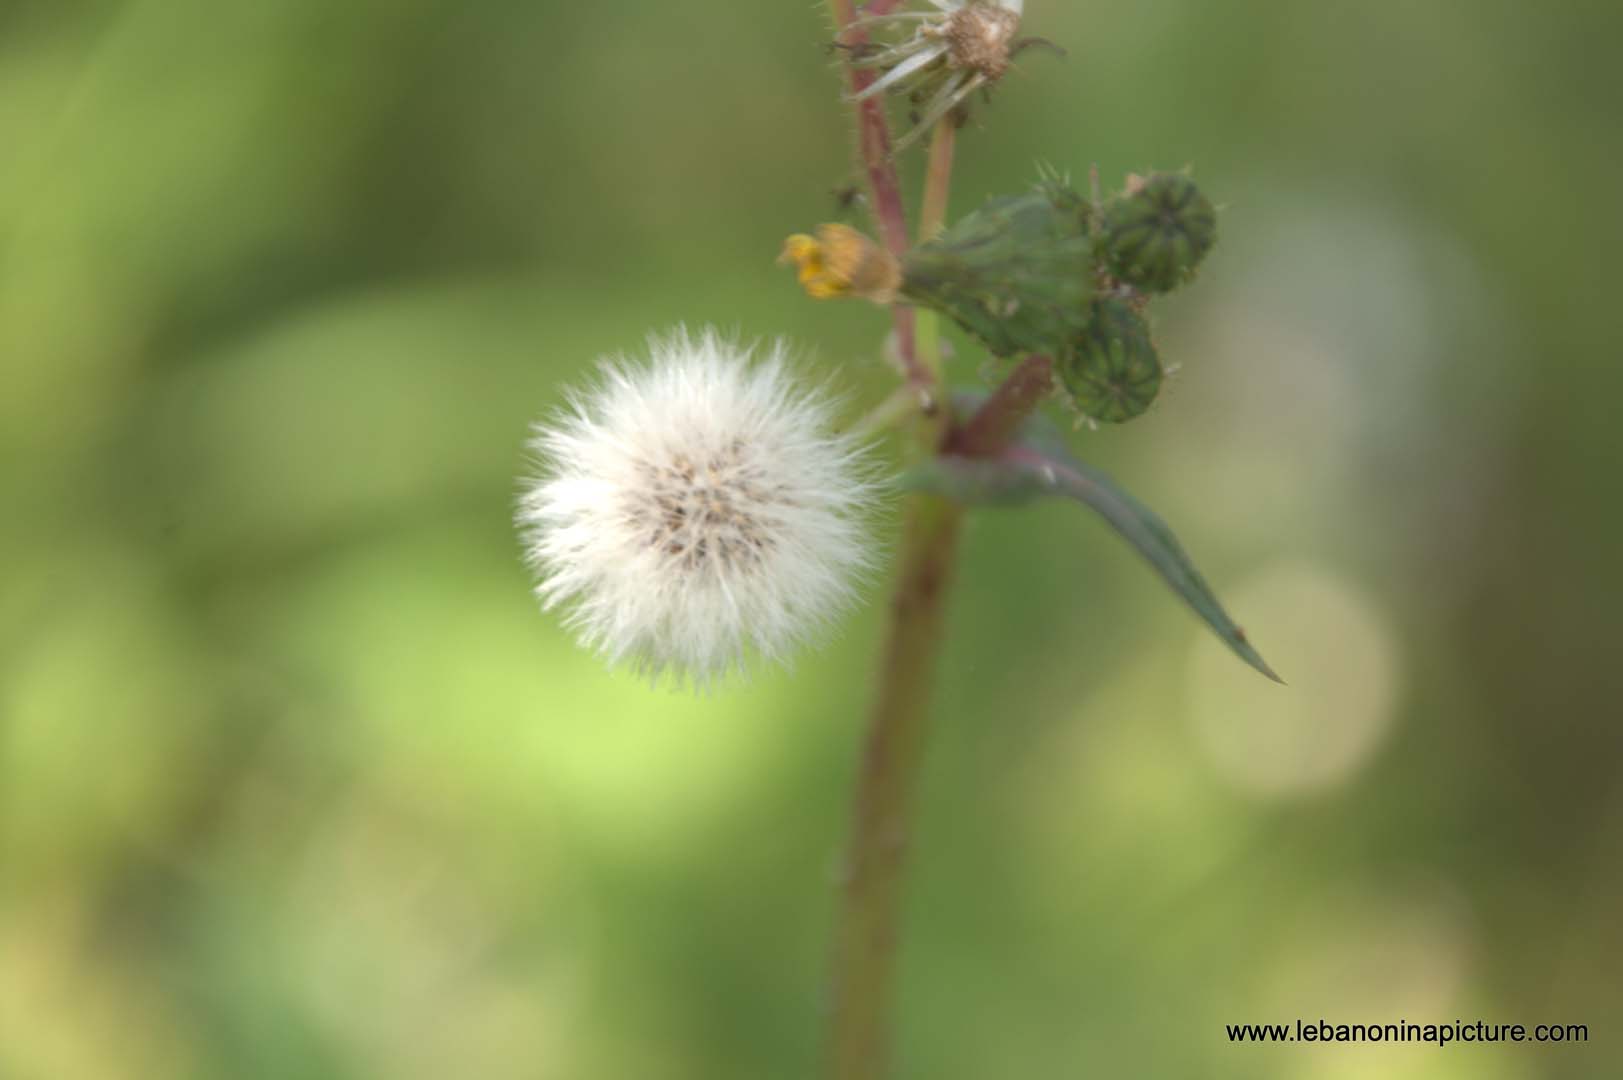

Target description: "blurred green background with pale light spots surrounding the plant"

left=0, top=0, right=1623, bottom=1080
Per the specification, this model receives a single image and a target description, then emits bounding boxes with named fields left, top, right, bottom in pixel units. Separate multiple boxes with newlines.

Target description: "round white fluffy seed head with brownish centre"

left=518, top=330, right=876, bottom=684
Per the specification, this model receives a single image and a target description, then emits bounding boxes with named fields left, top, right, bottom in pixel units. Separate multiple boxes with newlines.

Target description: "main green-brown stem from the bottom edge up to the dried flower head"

left=828, top=120, right=962, bottom=1080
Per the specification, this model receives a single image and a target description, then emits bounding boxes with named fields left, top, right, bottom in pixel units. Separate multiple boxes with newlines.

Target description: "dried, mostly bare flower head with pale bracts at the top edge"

left=852, top=0, right=1024, bottom=151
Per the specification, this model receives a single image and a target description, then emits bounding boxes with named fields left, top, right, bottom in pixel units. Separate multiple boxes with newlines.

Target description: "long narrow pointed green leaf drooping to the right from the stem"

left=902, top=445, right=1284, bottom=682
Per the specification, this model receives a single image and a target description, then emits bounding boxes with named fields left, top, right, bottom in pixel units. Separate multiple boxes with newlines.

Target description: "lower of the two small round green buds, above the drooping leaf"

left=1057, top=300, right=1162, bottom=424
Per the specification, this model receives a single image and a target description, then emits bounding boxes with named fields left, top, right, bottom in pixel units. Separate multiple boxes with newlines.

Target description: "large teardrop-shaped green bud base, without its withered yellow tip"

left=901, top=184, right=1094, bottom=356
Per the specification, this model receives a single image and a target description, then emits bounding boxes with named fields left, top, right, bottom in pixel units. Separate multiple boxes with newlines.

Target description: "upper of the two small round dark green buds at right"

left=1102, top=172, right=1217, bottom=292
